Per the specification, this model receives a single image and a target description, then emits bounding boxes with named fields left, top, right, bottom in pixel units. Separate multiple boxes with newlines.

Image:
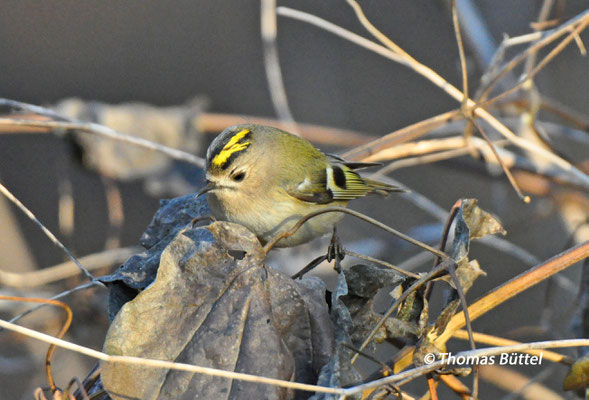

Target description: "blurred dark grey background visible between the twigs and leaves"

left=0, top=0, right=589, bottom=399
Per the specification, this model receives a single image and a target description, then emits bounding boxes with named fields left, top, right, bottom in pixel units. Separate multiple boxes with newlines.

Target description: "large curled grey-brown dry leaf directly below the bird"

left=101, top=222, right=333, bottom=400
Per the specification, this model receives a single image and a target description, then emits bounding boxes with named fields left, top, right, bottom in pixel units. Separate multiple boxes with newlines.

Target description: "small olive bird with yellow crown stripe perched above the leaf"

left=197, top=124, right=403, bottom=247
